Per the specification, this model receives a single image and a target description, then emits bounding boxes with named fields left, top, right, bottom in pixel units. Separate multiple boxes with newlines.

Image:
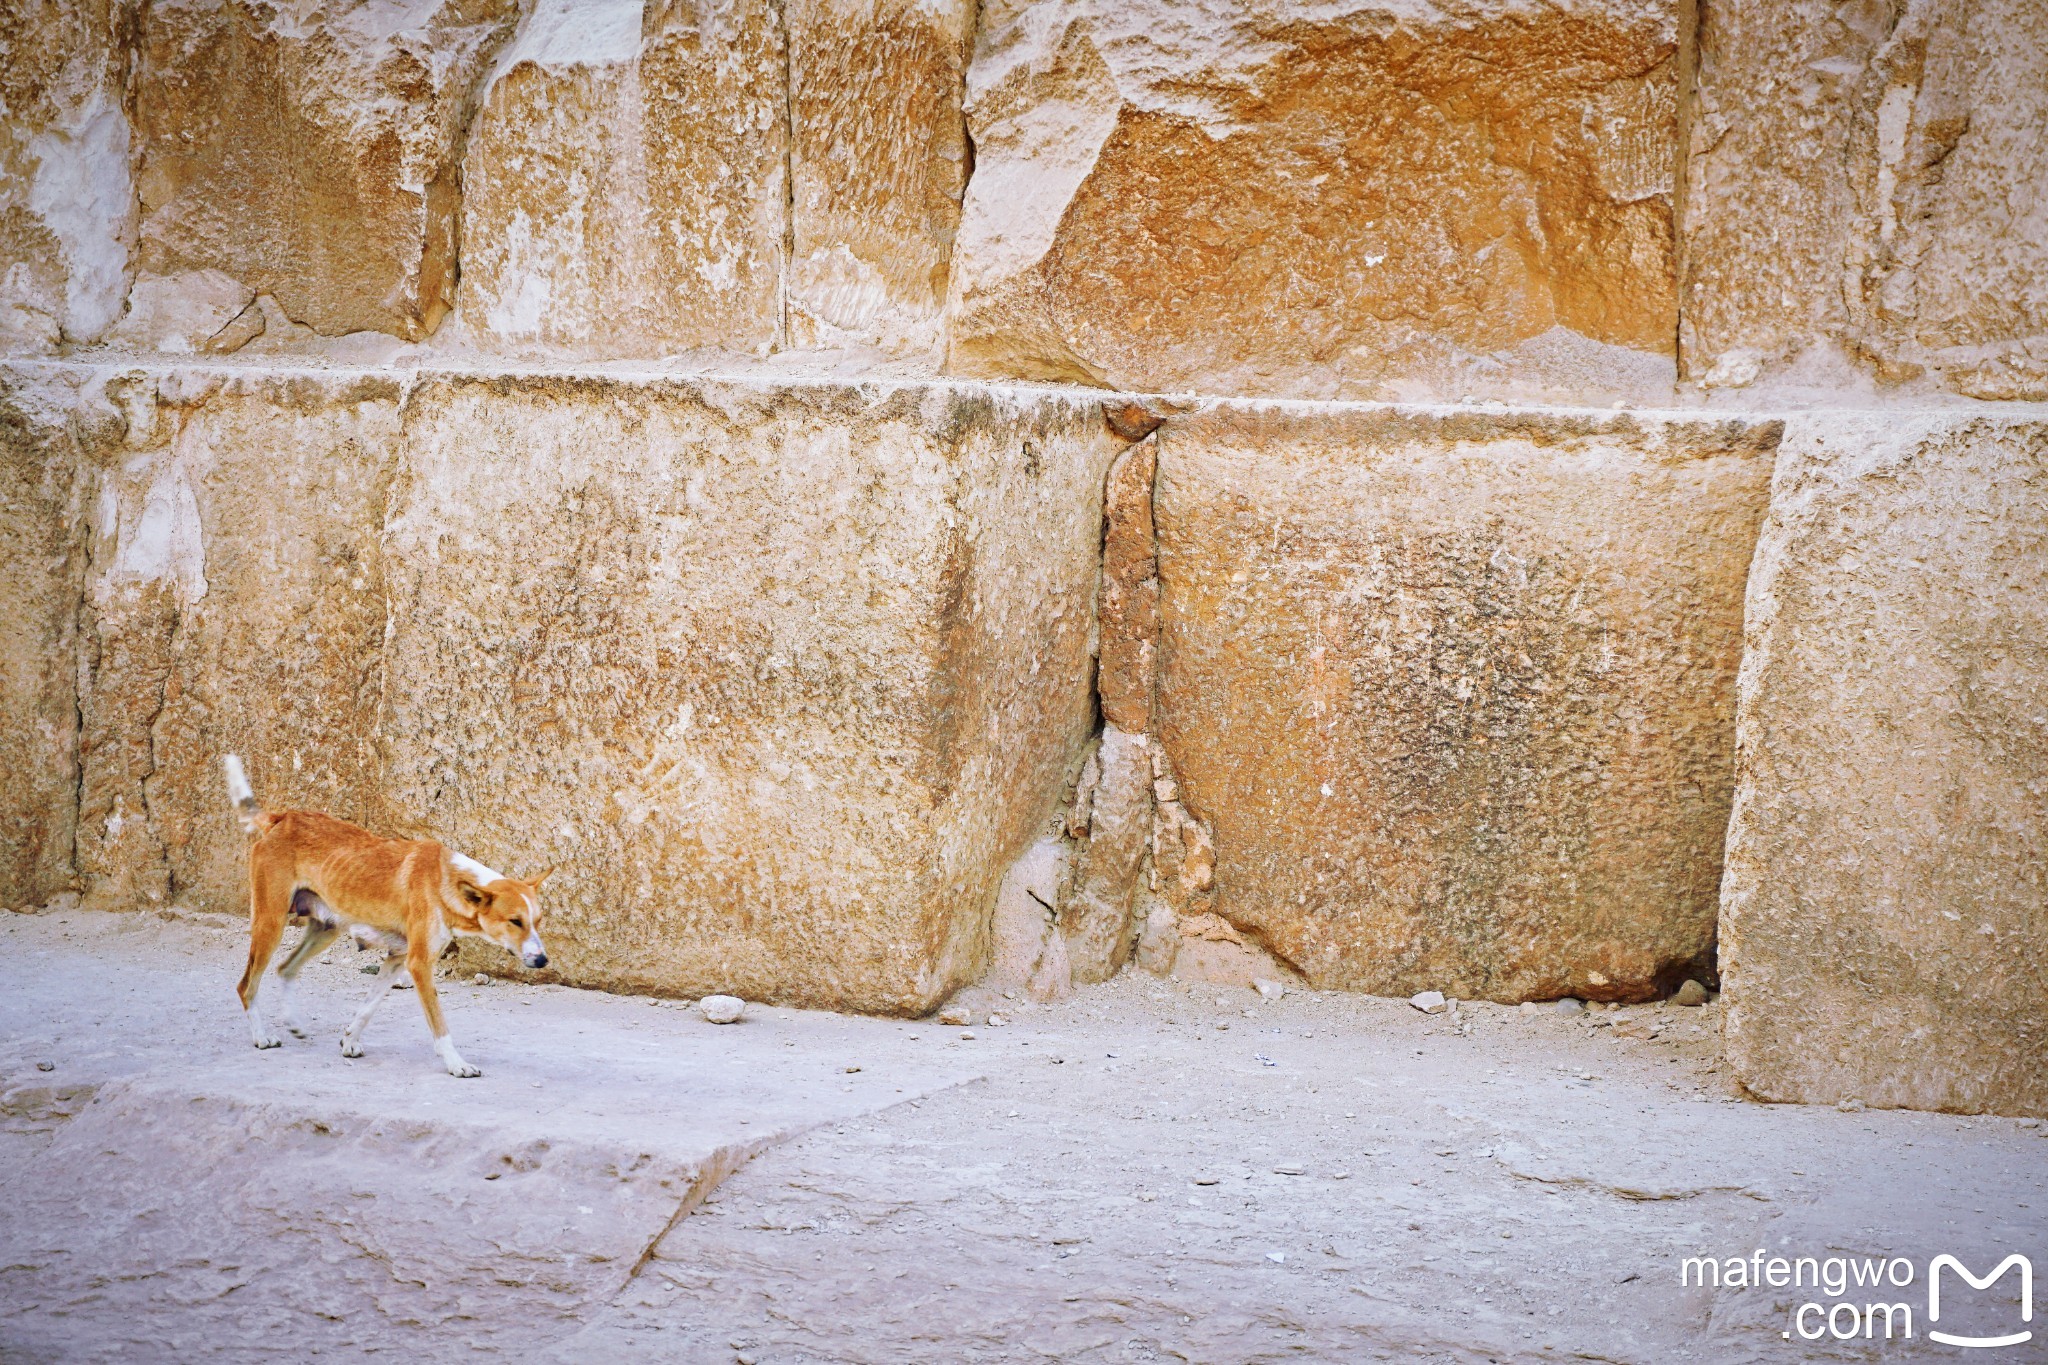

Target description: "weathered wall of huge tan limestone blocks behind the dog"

left=0, top=0, right=2048, bottom=1113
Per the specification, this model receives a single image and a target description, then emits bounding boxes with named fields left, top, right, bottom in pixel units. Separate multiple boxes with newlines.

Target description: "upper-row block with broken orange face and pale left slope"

left=950, top=0, right=1677, bottom=399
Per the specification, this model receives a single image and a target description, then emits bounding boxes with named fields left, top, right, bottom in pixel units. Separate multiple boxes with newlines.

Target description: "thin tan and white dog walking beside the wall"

left=221, top=753, right=553, bottom=1076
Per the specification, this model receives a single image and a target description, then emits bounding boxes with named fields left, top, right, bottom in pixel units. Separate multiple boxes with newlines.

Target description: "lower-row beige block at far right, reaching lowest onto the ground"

left=1722, top=409, right=2048, bottom=1115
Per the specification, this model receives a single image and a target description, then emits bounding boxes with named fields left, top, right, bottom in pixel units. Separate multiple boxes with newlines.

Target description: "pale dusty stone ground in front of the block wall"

left=0, top=913, right=2048, bottom=1363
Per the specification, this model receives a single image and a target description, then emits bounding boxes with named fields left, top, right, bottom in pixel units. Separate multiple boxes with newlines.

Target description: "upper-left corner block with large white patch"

left=0, top=0, right=135, bottom=354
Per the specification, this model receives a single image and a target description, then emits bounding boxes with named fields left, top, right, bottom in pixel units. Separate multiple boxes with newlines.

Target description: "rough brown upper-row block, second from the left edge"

left=133, top=0, right=516, bottom=340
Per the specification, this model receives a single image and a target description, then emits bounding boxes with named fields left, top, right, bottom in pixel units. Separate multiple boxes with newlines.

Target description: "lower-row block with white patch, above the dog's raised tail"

left=78, top=370, right=399, bottom=911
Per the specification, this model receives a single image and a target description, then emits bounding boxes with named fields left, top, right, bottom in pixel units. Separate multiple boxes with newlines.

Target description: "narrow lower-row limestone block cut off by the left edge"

left=0, top=368, right=88, bottom=907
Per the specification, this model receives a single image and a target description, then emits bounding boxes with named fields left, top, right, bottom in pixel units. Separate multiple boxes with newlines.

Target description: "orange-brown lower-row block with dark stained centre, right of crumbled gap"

left=1153, top=405, right=1778, bottom=1001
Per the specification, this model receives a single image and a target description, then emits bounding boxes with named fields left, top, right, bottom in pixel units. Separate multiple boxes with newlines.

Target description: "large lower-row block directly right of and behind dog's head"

left=381, top=377, right=1118, bottom=1013
